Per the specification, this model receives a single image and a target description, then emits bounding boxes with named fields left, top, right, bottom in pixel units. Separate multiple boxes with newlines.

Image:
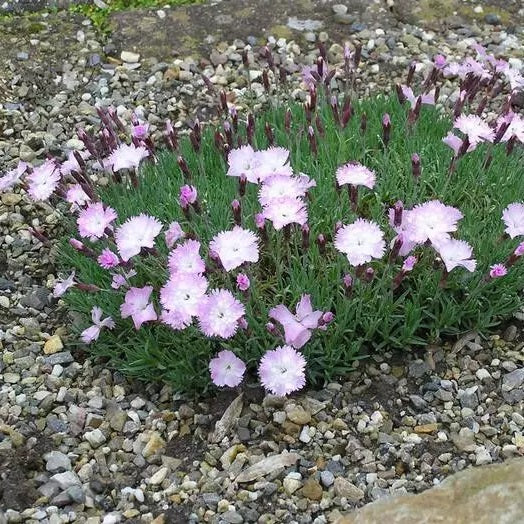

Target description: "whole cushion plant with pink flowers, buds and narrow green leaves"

left=0, top=42, right=524, bottom=395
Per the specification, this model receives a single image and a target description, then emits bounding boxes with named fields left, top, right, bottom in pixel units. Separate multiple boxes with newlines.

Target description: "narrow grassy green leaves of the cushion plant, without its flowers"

left=64, top=97, right=524, bottom=392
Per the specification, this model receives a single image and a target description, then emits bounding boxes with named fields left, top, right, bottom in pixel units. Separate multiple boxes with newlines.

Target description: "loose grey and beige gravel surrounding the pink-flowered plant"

left=0, top=4, right=524, bottom=524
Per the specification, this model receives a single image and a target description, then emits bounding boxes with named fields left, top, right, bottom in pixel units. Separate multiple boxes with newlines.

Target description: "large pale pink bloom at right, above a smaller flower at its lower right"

left=404, top=200, right=464, bottom=244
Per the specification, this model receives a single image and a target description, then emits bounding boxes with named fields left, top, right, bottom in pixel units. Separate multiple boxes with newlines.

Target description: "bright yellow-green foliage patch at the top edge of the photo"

left=70, top=0, right=202, bottom=33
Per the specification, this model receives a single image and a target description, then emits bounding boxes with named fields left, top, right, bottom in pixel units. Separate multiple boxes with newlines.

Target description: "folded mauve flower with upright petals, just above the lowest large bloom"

left=269, top=295, right=323, bottom=349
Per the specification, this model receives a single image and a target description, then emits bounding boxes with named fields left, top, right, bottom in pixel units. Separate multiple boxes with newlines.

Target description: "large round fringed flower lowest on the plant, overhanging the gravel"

left=258, top=346, right=306, bottom=396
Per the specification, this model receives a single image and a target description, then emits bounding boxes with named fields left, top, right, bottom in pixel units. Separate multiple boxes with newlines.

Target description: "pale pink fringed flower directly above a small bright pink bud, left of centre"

left=209, top=226, right=258, bottom=271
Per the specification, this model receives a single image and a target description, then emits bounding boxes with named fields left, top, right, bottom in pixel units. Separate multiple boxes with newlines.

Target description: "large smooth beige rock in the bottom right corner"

left=337, top=458, right=524, bottom=524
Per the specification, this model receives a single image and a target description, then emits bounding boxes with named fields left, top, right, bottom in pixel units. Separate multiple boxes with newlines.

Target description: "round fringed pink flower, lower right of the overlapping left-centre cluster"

left=198, top=289, right=245, bottom=338
